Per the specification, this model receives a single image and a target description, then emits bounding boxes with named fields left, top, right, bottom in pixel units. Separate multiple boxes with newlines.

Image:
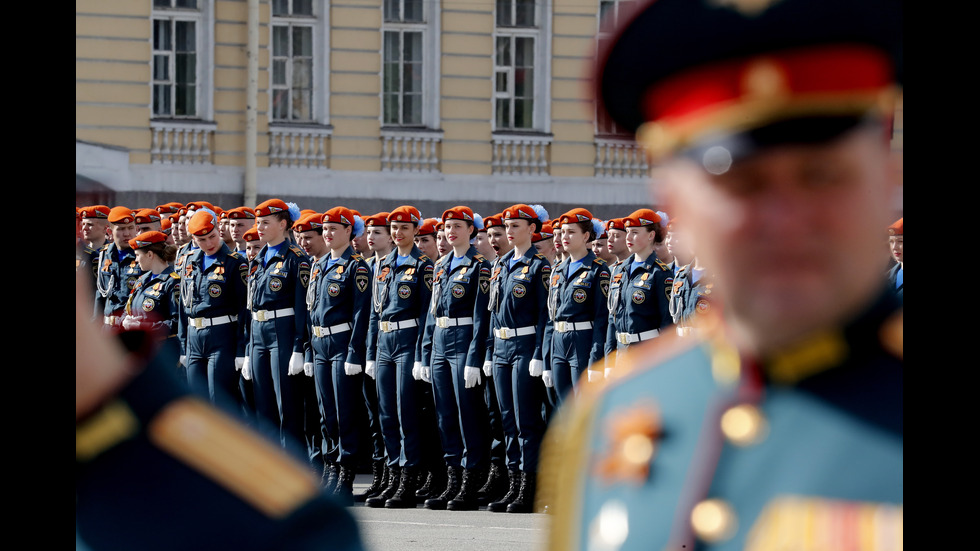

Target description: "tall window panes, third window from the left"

left=381, top=0, right=426, bottom=126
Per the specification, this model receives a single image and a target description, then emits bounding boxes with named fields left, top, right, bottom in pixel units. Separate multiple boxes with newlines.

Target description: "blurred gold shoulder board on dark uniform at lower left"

left=147, top=398, right=318, bottom=518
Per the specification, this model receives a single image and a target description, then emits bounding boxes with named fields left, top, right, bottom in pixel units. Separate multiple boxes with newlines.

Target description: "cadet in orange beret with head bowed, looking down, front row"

left=178, top=209, right=250, bottom=415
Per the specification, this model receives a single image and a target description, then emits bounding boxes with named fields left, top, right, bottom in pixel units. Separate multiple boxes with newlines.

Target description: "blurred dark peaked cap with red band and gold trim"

left=592, top=0, right=902, bottom=159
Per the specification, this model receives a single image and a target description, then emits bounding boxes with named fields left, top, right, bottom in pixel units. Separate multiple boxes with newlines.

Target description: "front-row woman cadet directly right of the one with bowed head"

left=243, top=199, right=310, bottom=457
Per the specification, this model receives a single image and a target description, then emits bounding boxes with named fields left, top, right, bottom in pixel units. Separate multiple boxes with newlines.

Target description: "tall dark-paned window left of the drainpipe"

left=152, top=0, right=203, bottom=118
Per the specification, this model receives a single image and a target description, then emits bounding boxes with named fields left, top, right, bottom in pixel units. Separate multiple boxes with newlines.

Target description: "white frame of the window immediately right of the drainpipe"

left=268, top=0, right=330, bottom=126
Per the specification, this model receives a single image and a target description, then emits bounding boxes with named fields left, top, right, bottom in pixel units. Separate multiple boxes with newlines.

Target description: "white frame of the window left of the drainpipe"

left=149, top=0, right=214, bottom=121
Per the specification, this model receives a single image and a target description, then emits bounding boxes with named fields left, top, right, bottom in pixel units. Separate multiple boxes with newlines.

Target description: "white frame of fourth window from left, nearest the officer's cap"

left=491, top=0, right=552, bottom=133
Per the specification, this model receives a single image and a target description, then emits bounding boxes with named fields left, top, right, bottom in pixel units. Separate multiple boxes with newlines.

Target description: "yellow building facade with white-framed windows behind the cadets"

left=75, top=0, right=901, bottom=218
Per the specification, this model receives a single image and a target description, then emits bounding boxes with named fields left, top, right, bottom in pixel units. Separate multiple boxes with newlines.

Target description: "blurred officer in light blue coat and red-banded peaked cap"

left=539, top=0, right=904, bottom=551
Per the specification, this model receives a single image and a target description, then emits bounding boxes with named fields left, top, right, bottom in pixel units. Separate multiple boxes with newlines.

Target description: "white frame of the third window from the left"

left=378, top=0, right=442, bottom=130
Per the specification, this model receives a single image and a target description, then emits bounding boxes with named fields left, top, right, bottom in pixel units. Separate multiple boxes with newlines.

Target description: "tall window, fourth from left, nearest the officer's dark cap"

left=493, top=0, right=548, bottom=130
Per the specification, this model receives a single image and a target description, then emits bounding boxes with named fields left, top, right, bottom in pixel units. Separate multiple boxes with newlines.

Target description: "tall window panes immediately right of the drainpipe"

left=272, top=0, right=316, bottom=122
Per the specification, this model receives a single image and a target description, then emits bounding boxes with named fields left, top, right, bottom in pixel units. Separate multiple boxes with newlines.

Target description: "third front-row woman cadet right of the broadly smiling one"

left=548, top=208, right=609, bottom=406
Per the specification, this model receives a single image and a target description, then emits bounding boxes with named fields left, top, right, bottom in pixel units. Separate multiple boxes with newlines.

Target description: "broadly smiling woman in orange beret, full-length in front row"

left=365, top=206, right=432, bottom=508
